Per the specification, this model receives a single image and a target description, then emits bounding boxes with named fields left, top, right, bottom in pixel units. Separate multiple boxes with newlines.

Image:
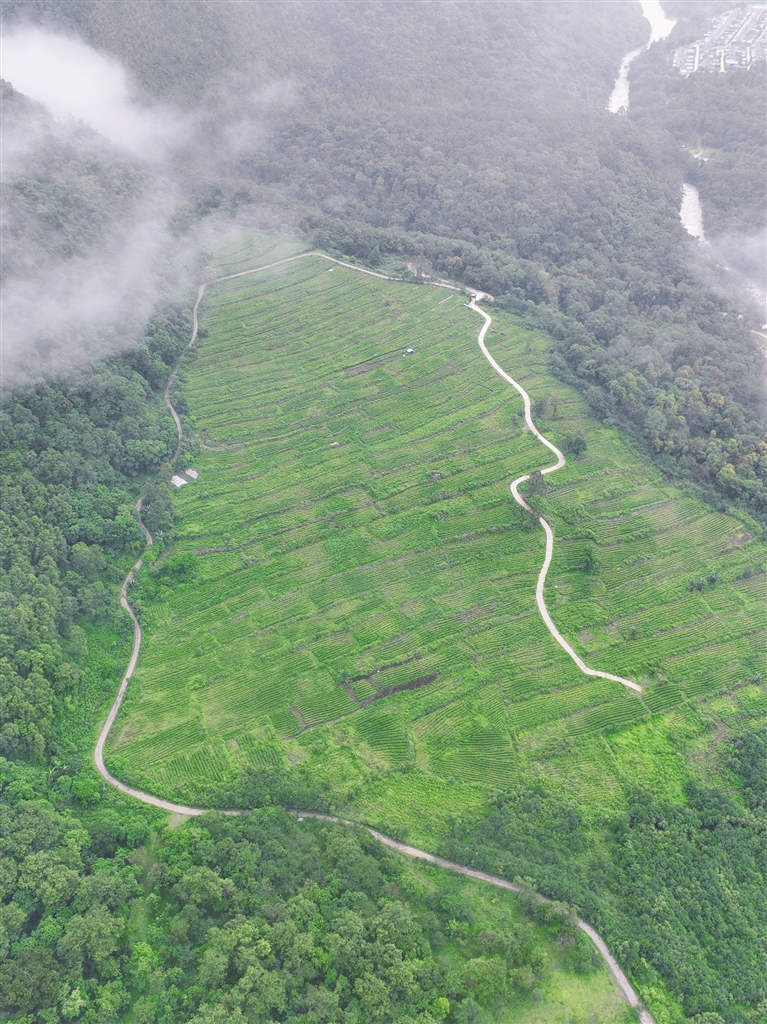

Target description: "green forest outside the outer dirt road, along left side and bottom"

left=0, top=232, right=626, bottom=1024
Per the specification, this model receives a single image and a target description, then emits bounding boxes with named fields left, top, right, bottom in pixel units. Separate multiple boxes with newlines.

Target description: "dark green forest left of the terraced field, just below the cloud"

left=0, top=310, right=190, bottom=762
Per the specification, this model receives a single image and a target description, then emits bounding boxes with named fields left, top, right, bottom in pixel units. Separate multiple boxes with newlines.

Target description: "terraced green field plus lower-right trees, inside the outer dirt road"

left=98, top=243, right=767, bottom=1024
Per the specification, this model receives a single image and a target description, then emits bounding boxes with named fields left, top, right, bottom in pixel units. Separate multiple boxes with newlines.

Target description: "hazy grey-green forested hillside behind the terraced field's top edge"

left=4, top=0, right=767, bottom=518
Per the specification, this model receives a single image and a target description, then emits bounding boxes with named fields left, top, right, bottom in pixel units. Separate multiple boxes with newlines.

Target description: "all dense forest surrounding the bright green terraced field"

left=0, top=0, right=767, bottom=1024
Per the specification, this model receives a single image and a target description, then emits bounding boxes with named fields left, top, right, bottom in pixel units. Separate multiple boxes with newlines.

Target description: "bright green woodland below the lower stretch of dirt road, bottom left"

left=0, top=760, right=630, bottom=1024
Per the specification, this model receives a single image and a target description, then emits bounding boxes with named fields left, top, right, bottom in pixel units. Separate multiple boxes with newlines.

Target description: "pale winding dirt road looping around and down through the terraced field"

left=93, top=252, right=654, bottom=1024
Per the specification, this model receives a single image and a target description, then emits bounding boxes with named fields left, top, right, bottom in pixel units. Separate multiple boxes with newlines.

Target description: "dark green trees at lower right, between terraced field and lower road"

left=442, top=730, right=767, bottom=1024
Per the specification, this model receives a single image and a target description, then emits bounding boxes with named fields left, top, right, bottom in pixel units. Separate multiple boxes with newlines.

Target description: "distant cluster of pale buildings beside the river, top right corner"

left=674, top=3, right=767, bottom=75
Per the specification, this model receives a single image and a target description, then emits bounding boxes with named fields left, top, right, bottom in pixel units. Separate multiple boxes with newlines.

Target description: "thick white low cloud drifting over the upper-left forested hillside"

left=0, top=26, right=292, bottom=386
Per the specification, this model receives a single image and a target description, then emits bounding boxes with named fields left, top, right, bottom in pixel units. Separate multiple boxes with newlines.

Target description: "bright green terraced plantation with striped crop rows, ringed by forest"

left=108, top=239, right=767, bottom=838
